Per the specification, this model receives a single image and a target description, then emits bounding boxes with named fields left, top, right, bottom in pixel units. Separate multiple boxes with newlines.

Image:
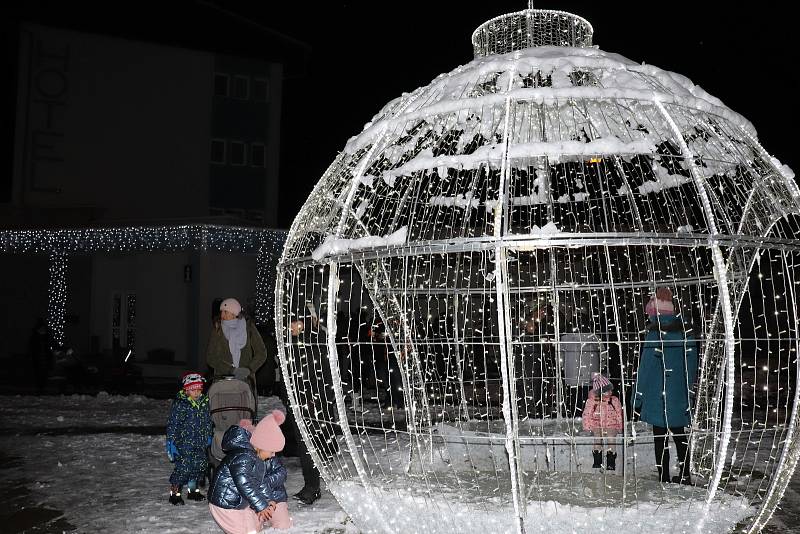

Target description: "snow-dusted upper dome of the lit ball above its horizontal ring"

left=284, top=10, right=800, bottom=268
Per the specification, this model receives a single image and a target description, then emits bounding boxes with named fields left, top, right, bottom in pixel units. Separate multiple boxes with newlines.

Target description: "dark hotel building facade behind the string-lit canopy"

left=0, top=23, right=300, bottom=390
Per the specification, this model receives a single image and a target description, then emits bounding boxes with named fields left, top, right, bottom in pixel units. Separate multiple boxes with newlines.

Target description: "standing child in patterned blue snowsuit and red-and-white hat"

left=167, top=373, right=214, bottom=504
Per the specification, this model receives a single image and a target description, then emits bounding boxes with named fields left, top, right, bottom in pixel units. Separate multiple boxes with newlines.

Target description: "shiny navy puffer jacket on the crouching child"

left=208, top=426, right=269, bottom=512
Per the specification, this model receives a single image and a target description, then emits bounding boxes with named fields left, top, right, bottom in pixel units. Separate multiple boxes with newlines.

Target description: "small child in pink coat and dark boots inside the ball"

left=583, top=373, right=623, bottom=471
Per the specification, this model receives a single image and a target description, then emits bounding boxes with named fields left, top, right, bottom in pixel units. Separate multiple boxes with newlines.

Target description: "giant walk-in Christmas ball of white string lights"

left=276, top=10, right=800, bottom=532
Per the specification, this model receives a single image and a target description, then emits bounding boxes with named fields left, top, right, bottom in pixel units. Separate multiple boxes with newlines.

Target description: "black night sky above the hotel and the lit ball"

left=3, top=0, right=800, bottom=228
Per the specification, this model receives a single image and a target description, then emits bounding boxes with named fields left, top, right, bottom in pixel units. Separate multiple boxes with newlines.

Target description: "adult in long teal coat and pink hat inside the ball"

left=633, top=288, right=697, bottom=484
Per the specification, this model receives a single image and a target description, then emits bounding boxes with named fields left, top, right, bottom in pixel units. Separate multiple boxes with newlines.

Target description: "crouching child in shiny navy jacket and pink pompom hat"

left=208, top=410, right=292, bottom=534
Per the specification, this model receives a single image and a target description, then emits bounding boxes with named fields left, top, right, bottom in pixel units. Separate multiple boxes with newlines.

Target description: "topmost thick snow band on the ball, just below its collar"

left=345, top=46, right=756, bottom=152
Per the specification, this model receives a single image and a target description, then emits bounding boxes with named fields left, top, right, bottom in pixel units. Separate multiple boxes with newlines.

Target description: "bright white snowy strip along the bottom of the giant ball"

left=330, top=481, right=755, bottom=534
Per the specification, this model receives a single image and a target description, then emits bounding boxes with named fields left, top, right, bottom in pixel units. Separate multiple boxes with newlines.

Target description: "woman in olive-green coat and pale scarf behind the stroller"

left=206, top=298, right=267, bottom=381
